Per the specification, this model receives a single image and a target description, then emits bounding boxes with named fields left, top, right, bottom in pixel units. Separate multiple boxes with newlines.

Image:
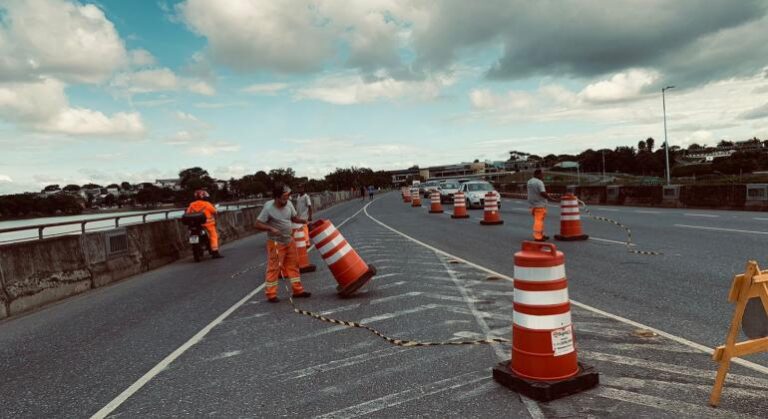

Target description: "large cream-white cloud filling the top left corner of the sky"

left=0, top=0, right=128, bottom=83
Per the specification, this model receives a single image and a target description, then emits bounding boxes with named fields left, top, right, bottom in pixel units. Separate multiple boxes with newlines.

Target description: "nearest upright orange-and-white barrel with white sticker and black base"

left=493, top=241, right=600, bottom=401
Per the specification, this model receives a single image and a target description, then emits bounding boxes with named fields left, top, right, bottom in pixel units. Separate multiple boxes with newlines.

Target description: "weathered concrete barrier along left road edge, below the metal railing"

left=0, top=191, right=352, bottom=319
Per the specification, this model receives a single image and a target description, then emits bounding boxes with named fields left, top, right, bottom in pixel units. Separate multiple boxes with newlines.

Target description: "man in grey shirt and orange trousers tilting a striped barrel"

left=256, top=182, right=312, bottom=303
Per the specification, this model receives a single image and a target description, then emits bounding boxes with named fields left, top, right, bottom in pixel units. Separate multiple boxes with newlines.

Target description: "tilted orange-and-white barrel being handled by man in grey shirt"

left=309, top=220, right=376, bottom=297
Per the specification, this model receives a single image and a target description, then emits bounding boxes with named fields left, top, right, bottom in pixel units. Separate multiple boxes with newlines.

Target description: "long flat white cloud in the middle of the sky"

left=296, top=75, right=454, bottom=105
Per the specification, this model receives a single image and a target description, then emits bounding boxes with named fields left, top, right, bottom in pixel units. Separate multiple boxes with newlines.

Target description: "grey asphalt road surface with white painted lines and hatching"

left=0, top=194, right=768, bottom=417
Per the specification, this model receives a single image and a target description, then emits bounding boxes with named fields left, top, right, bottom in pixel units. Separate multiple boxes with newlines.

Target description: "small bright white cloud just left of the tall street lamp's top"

left=579, top=69, right=659, bottom=103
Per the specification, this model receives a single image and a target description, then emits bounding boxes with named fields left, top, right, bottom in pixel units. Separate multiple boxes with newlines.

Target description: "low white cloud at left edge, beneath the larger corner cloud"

left=0, top=79, right=146, bottom=136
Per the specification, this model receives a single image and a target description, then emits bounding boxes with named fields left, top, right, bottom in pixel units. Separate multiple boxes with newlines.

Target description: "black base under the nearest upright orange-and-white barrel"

left=493, top=361, right=600, bottom=402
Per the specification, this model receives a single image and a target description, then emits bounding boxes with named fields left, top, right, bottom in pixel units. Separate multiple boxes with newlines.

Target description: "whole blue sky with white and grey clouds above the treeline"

left=0, top=0, right=768, bottom=193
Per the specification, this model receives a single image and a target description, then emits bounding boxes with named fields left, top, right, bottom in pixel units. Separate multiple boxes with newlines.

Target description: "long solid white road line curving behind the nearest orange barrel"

left=363, top=204, right=768, bottom=374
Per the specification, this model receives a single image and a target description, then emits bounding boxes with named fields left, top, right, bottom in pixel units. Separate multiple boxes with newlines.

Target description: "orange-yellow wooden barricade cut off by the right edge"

left=709, top=261, right=768, bottom=407
